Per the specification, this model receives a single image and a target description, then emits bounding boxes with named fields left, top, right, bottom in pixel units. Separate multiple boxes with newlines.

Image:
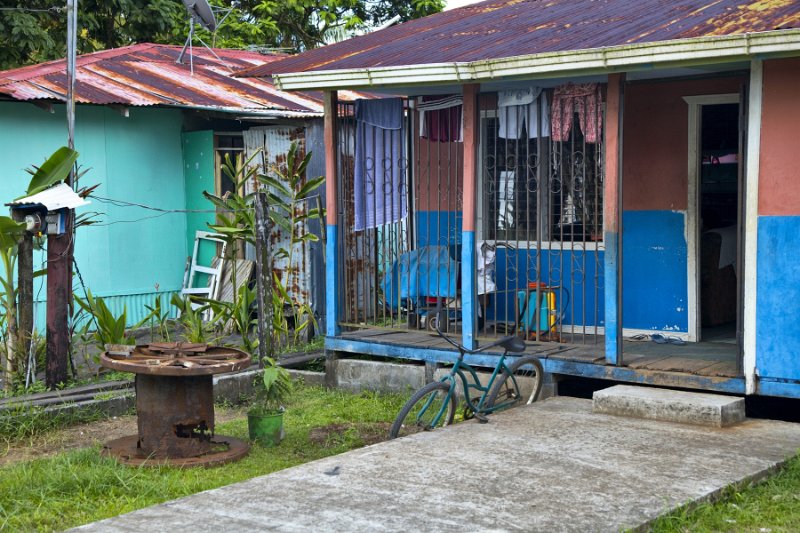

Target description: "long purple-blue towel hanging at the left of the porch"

left=353, top=98, right=407, bottom=231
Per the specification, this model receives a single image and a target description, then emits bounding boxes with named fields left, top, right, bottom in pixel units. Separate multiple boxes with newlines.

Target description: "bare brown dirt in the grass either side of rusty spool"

left=0, top=407, right=245, bottom=466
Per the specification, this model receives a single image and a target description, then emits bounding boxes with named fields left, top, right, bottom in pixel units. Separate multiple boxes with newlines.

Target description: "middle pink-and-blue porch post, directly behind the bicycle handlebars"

left=461, top=84, right=480, bottom=349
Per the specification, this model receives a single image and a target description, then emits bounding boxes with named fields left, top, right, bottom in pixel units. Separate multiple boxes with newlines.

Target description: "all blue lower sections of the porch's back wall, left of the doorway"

left=415, top=211, right=688, bottom=332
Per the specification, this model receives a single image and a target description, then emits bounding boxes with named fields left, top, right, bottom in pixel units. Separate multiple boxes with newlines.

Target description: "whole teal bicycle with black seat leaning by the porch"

left=389, top=327, right=543, bottom=439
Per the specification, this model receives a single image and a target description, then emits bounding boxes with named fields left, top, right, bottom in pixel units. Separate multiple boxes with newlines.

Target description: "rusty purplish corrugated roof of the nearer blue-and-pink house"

left=242, top=0, right=800, bottom=77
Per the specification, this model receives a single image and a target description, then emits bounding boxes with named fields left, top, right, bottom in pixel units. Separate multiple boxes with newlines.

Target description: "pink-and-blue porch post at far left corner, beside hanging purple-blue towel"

left=324, top=91, right=339, bottom=337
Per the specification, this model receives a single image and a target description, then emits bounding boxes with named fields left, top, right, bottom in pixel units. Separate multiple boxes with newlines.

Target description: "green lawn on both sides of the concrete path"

left=0, top=387, right=800, bottom=533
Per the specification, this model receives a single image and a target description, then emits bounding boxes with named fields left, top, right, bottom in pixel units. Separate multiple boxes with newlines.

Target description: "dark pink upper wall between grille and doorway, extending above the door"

left=622, top=78, right=745, bottom=211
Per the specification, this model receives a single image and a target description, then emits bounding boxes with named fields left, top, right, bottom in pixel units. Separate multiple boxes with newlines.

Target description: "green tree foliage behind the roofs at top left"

left=0, top=0, right=444, bottom=69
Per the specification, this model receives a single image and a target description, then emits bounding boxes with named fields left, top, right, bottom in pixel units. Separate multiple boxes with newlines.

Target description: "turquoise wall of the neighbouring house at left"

left=0, top=102, right=187, bottom=324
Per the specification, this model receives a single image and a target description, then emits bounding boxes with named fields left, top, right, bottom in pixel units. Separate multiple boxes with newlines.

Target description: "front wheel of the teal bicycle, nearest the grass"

left=389, top=381, right=456, bottom=439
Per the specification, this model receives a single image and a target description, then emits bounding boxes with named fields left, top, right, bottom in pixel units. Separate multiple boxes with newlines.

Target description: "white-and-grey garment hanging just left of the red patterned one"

left=497, top=87, right=550, bottom=139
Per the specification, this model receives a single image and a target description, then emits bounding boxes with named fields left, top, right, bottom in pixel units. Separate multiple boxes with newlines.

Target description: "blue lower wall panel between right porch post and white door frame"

left=622, top=211, right=689, bottom=332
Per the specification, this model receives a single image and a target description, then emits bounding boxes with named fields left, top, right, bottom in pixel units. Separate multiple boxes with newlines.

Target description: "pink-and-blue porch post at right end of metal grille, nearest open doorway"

left=603, top=73, right=625, bottom=365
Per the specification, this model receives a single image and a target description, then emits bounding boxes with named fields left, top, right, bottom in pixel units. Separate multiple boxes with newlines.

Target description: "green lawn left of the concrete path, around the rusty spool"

left=0, top=387, right=405, bottom=531
